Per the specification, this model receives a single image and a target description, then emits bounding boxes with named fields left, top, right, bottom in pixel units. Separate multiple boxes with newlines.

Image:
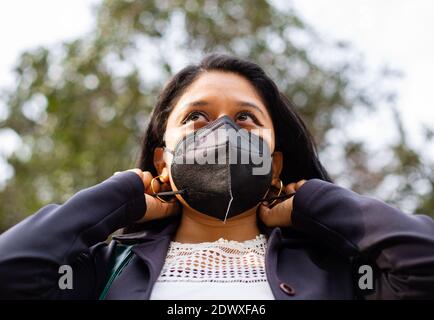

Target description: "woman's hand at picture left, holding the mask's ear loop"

left=114, top=168, right=181, bottom=223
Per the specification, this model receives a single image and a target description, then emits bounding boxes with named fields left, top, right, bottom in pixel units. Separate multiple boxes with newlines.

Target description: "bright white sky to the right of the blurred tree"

left=291, top=0, right=434, bottom=159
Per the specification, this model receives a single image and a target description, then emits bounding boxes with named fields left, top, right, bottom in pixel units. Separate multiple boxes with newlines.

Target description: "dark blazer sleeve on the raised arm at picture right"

left=292, top=179, right=434, bottom=299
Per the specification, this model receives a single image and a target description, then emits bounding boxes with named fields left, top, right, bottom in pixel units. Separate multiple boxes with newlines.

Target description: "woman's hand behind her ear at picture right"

left=258, top=180, right=306, bottom=227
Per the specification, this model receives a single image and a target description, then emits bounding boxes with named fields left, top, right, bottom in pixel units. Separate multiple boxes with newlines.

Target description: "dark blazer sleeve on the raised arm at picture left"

left=0, top=172, right=146, bottom=299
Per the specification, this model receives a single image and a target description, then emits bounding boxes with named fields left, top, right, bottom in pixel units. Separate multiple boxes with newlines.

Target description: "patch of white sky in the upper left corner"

left=0, top=0, right=99, bottom=87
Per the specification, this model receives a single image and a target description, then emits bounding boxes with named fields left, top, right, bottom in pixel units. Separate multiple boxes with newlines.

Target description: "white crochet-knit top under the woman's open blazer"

left=150, top=234, right=274, bottom=300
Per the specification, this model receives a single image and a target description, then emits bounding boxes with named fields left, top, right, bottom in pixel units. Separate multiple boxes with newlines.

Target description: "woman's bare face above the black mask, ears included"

left=154, top=71, right=282, bottom=205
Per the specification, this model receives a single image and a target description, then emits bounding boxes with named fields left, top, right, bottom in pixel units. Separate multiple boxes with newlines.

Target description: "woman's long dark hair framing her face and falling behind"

left=127, top=53, right=331, bottom=235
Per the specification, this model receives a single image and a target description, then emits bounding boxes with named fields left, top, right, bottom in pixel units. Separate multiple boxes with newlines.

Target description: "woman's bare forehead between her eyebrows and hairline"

left=175, top=71, right=262, bottom=102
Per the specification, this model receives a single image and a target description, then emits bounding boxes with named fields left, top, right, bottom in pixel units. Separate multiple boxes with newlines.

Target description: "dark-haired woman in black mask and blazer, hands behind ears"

left=0, top=54, right=434, bottom=299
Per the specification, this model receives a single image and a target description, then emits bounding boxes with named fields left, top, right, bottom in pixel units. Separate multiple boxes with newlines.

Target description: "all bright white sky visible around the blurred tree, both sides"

left=0, top=0, right=434, bottom=185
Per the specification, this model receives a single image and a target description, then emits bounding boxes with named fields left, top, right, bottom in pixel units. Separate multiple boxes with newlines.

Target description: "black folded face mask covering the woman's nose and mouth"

left=159, top=116, right=272, bottom=221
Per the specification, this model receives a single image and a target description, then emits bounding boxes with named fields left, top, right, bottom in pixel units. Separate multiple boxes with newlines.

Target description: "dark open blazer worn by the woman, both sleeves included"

left=0, top=172, right=434, bottom=299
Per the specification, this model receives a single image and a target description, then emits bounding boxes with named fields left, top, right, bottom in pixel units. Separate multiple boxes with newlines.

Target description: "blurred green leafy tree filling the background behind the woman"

left=0, top=0, right=434, bottom=231
